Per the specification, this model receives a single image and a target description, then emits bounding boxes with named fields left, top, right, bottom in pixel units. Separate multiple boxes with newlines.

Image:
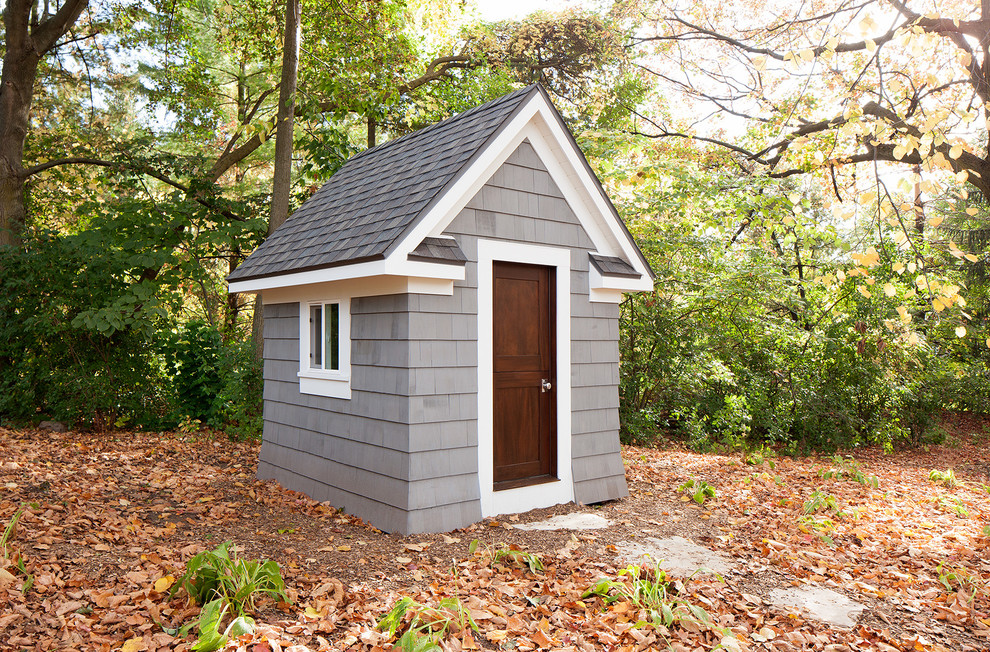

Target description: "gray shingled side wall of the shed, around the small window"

left=258, top=295, right=411, bottom=532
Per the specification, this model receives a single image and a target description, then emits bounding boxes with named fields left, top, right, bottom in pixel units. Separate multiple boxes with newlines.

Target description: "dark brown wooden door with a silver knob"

left=492, top=261, right=557, bottom=490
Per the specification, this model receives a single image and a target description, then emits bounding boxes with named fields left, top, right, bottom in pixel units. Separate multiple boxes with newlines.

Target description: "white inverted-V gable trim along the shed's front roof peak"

left=387, top=93, right=653, bottom=290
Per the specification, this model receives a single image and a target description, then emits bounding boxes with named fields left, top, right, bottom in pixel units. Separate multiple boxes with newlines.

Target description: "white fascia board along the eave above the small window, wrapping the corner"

left=227, top=256, right=464, bottom=294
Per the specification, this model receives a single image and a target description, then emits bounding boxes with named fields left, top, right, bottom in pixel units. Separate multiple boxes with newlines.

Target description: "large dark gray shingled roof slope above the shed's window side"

left=227, top=85, right=539, bottom=281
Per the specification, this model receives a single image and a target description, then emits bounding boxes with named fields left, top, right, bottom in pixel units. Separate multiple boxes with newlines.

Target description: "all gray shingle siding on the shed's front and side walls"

left=259, top=136, right=627, bottom=532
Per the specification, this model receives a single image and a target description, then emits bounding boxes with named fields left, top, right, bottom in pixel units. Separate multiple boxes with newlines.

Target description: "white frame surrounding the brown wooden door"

left=478, top=239, right=574, bottom=517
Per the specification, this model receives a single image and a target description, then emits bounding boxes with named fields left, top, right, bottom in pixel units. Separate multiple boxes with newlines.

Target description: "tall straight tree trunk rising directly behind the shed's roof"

left=252, top=0, right=300, bottom=360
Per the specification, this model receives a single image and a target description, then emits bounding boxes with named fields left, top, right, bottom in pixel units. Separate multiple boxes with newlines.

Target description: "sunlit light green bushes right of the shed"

left=619, top=182, right=990, bottom=452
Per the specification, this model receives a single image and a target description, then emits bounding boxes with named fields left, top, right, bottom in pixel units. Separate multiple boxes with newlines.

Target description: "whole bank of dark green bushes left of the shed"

left=0, top=231, right=262, bottom=437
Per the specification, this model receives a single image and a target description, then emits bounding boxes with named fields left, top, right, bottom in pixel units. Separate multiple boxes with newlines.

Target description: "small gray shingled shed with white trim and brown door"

left=228, top=85, right=653, bottom=533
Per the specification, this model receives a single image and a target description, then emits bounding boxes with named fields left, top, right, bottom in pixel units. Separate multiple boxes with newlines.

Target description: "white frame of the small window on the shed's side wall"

left=298, top=297, right=351, bottom=399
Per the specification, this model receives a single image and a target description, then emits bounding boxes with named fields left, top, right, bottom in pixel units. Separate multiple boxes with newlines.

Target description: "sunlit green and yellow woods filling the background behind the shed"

left=0, top=0, right=990, bottom=449
